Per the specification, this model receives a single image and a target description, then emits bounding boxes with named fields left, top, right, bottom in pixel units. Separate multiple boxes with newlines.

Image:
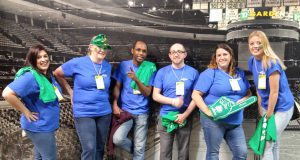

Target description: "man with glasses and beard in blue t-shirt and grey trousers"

left=153, top=43, right=198, bottom=160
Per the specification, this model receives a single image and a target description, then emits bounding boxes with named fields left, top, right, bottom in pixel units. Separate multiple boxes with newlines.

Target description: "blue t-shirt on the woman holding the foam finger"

left=194, top=68, right=250, bottom=125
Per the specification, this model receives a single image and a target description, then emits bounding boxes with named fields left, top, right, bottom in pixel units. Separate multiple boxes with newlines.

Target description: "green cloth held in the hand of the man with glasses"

left=161, top=111, right=186, bottom=133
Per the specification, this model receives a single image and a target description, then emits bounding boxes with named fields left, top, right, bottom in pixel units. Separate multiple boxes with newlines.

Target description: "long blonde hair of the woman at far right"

left=248, top=30, right=286, bottom=70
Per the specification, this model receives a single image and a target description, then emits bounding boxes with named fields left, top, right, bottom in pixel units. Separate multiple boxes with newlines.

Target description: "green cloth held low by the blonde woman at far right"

left=248, top=114, right=277, bottom=155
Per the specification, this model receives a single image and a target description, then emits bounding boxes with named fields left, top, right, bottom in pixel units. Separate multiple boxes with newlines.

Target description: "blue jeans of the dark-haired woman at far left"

left=25, top=130, right=56, bottom=160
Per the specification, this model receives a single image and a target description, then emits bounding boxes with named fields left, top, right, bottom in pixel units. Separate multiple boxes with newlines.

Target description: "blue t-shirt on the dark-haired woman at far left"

left=8, top=72, right=61, bottom=132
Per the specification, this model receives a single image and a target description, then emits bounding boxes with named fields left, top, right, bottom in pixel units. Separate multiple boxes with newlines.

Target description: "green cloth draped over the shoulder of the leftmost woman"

left=15, top=67, right=57, bottom=103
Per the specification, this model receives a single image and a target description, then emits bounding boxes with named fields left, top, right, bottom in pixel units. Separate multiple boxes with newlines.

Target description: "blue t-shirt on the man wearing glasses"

left=154, top=65, right=198, bottom=116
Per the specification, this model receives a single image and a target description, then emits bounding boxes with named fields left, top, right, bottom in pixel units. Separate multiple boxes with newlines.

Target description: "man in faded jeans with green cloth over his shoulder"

left=113, top=41, right=156, bottom=160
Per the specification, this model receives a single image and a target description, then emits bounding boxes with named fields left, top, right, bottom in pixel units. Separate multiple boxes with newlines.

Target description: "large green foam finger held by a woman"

left=209, top=96, right=257, bottom=121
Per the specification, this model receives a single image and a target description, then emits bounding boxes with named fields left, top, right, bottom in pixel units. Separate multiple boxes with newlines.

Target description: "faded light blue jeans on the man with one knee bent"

left=113, top=114, right=149, bottom=160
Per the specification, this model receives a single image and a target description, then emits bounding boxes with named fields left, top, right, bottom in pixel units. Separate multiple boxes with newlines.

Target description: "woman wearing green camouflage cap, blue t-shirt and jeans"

left=55, top=34, right=112, bottom=160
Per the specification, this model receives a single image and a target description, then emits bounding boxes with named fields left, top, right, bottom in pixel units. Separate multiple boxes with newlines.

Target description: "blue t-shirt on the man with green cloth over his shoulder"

left=113, top=60, right=155, bottom=114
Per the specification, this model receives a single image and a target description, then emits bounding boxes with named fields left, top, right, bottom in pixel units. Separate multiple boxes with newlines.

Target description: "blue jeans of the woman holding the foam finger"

left=200, top=115, right=247, bottom=160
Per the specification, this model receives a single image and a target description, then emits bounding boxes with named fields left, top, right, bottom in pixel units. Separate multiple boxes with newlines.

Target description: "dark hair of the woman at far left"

left=24, top=44, right=48, bottom=73
